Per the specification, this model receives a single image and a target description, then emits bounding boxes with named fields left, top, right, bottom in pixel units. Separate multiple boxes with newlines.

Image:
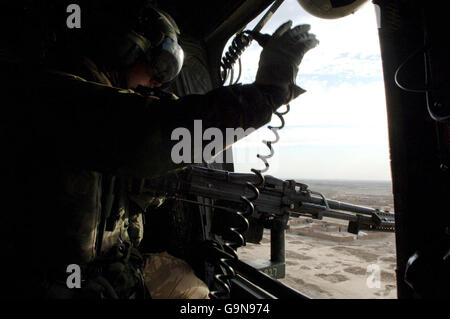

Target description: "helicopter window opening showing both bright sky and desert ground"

left=226, top=0, right=397, bottom=298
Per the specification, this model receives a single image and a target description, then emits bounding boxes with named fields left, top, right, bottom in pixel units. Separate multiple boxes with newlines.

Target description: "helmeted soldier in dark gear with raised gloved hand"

left=1, top=0, right=318, bottom=298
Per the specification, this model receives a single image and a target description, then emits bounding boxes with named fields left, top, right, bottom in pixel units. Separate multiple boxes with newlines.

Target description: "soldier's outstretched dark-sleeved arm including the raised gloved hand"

left=5, top=22, right=318, bottom=177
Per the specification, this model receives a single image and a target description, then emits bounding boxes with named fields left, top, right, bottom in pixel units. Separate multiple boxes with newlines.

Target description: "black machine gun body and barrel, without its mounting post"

left=144, top=166, right=395, bottom=234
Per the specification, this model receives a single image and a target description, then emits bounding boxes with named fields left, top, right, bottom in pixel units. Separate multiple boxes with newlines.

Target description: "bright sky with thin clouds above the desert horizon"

left=229, top=0, right=391, bottom=181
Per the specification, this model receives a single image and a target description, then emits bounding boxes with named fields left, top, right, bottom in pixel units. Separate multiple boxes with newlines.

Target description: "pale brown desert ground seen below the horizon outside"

left=238, top=181, right=397, bottom=299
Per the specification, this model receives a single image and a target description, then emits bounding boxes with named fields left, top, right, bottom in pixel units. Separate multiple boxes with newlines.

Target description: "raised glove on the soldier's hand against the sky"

left=251, top=21, right=319, bottom=109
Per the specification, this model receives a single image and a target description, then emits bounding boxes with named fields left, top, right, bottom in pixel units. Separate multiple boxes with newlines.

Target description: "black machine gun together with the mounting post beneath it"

left=143, top=166, right=394, bottom=283
